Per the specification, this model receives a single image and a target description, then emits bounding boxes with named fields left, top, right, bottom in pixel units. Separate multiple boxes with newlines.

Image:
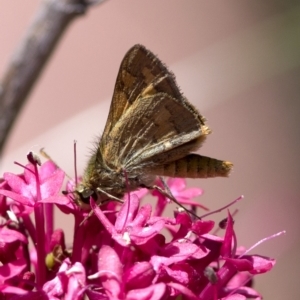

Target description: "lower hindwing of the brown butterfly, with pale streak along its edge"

left=103, top=93, right=207, bottom=170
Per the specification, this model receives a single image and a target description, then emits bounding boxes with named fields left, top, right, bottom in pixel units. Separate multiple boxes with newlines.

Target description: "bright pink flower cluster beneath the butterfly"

left=0, top=155, right=275, bottom=300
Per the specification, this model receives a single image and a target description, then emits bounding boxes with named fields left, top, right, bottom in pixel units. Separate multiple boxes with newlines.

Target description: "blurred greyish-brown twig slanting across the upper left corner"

left=0, top=0, right=102, bottom=153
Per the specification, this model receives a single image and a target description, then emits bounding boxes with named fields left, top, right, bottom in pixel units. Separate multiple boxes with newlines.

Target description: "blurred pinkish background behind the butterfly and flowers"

left=0, top=0, right=300, bottom=300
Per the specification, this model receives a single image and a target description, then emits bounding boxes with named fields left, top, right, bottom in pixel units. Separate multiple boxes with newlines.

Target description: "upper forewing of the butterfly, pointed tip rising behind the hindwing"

left=101, top=45, right=204, bottom=149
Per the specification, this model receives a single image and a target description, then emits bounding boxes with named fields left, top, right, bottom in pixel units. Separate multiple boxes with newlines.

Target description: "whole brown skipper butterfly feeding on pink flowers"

left=76, top=45, right=233, bottom=204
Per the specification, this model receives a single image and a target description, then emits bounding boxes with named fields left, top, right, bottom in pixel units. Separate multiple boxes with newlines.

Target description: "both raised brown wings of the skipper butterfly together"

left=100, top=45, right=208, bottom=169
